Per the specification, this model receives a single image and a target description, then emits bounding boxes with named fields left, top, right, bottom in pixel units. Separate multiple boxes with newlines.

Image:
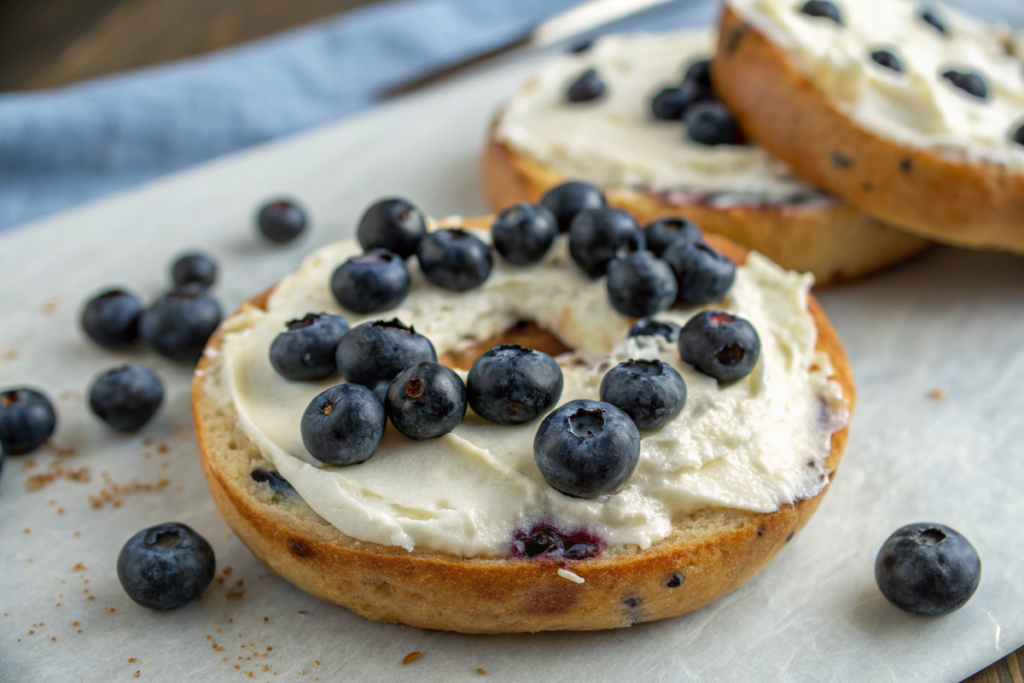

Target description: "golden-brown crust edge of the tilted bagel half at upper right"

left=712, top=6, right=1024, bottom=252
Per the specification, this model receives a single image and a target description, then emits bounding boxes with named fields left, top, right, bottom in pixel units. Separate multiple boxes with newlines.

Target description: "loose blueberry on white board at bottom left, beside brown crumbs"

left=118, top=522, right=216, bottom=611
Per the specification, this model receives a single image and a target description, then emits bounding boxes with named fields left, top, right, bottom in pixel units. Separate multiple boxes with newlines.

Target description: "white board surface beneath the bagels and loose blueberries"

left=0, top=44, right=1024, bottom=681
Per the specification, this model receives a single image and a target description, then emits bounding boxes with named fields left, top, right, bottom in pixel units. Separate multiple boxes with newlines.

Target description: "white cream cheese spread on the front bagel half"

left=207, top=231, right=848, bottom=557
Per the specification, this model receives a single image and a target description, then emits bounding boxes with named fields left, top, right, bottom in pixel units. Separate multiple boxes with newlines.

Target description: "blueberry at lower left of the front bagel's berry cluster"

left=300, top=384, right=387, bottom=466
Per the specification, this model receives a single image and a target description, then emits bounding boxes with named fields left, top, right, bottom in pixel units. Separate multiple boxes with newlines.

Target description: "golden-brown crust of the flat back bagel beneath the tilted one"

left=481, top=119, right=928, bottom=285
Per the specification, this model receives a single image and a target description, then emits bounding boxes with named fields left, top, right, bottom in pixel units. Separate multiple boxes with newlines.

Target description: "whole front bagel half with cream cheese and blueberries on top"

left=193, top=193, right=854, bottom=633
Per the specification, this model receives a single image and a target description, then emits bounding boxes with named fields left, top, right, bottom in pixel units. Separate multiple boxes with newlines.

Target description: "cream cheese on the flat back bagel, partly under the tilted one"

left=496, top=30, right=833, bottom=206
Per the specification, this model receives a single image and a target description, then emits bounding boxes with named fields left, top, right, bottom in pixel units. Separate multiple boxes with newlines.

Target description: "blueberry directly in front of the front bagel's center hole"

left=466, top=344, right=565, bottom=425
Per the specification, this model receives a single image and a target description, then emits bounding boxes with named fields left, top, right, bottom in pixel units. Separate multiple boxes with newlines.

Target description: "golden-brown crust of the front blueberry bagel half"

left=193, top=236, right=854, bottom=633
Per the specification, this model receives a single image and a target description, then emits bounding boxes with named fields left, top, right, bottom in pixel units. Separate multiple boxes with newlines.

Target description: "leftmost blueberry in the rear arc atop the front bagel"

left=331, top=248, right=412, bottom=313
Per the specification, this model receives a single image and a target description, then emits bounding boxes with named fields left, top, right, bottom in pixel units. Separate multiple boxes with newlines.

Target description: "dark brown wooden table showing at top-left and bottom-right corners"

left=0, top=0, right=1024, bottom=683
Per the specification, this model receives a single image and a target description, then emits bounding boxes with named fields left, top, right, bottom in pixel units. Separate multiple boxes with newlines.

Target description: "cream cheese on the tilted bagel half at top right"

left=728, top=0, right=1024, bottom=169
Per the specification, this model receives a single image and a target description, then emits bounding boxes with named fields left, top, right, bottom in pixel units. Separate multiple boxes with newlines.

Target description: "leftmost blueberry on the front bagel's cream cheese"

left=270, top=313, right=350, bottom=382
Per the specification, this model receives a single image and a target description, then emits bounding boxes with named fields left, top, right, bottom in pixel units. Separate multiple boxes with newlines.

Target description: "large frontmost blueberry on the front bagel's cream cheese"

left=534, top=400, right=640, bottom=498
